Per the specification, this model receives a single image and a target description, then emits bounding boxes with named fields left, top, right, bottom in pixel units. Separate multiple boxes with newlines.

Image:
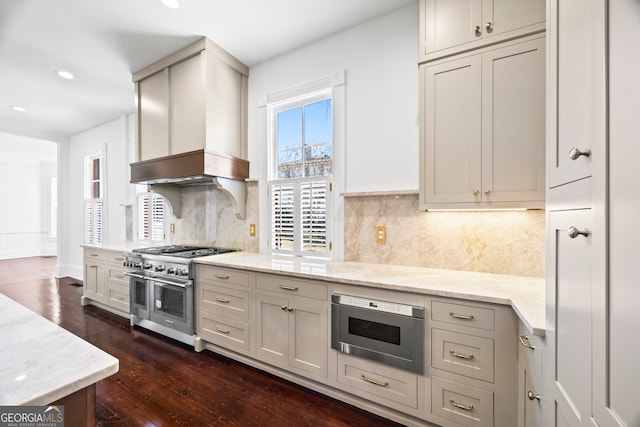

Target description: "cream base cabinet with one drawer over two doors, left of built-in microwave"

left=255, top=274, right=329, bottom=380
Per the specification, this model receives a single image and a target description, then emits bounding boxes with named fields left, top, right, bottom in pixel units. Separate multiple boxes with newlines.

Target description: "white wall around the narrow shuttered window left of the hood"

left=57, top=115, right=133, bottom=279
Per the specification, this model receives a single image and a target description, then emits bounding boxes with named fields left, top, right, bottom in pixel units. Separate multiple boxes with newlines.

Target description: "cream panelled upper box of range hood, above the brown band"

left=133, top=38, right=249, bottom=161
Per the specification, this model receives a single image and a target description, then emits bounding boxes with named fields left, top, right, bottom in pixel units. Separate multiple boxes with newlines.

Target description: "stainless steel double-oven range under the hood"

left=124, top=245, right=235, bottom=345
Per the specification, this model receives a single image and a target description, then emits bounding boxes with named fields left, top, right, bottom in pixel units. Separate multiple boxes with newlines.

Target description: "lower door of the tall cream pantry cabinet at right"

left=544, top=209, right=593, bottom=427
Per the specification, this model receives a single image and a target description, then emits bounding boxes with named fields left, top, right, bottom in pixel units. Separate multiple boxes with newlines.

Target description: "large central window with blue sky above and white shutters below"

left=269, top=93, right=334, bottom=257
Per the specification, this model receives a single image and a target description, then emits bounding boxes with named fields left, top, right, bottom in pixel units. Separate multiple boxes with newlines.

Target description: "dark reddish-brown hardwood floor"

left=0, top=257, right=398, bottom=427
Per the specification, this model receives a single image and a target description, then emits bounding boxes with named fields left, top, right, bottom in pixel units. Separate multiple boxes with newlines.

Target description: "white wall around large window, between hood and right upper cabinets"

left=249, top=3, right=419, bottom=192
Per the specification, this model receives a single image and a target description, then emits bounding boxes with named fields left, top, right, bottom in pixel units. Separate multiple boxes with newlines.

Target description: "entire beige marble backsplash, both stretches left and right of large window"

left=166, top=180, right=545, bottom=277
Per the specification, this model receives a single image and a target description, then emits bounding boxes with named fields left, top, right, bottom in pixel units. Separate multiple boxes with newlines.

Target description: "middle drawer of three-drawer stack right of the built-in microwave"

left=431, top=329, right=494, bottom=382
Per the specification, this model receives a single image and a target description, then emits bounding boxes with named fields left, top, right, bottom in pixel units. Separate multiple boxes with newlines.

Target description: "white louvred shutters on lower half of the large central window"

left=269, top=176, right=331, bottom=256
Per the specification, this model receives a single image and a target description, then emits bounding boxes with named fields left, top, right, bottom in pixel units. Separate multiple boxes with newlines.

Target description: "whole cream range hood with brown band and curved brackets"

left=130, top=37, right=249, bottom=218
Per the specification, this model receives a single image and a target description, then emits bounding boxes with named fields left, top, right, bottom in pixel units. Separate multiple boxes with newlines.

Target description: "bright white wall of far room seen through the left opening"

left=0, top=133, right=57, bottom=259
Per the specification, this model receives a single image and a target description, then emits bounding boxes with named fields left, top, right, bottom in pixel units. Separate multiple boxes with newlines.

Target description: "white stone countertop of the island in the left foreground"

left=0, top=294, right=119, bottom=406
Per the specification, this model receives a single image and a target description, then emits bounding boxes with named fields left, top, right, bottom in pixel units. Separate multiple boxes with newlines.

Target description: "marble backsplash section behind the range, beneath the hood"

left=171, top=181, right=259, bottom=252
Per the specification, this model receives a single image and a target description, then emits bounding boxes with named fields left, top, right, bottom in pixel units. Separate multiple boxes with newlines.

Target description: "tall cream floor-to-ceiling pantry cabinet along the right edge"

left=540, top=0, right=640, bottom=427
